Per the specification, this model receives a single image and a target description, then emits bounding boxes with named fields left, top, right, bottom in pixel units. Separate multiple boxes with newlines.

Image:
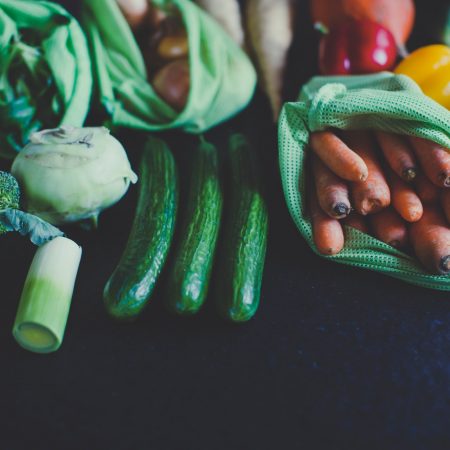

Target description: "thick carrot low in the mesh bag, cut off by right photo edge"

left=409, top=205, right=450, bottom=275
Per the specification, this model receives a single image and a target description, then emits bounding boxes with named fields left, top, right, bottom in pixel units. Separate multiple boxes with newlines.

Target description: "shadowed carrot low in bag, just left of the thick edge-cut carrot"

left=370, top=207, right=408, bottom=248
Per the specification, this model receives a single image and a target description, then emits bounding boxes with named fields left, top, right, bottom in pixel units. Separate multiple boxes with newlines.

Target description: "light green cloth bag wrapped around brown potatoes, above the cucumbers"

left=83, top=0, right=256, bottom=133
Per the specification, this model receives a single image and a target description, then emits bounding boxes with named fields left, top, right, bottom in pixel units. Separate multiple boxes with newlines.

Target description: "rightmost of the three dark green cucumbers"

left=215, top=134, right=268, bottom=322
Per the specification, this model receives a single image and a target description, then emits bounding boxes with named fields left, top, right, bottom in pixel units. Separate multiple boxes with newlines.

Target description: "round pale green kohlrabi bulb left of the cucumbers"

left=11, top=126, right=137, bottom=225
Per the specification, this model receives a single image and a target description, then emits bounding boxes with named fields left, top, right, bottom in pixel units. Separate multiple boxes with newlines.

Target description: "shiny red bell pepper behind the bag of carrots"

left=319, top=19, right=397, bottom=75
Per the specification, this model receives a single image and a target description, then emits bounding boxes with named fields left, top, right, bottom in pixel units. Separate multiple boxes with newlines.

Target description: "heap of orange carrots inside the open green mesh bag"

left=308, top=131, right=450, bottom=274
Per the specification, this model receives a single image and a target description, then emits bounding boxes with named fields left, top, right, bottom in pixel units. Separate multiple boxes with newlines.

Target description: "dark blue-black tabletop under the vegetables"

left=0, top=0, right=450, bottom=450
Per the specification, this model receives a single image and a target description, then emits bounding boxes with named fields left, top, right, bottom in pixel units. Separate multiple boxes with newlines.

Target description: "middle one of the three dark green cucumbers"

left=166, top=142, right=222, bottom=314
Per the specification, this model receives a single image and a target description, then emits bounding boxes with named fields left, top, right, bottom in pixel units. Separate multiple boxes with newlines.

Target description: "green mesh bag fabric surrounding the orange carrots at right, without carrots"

left=278, top=72, right=450, bottom=290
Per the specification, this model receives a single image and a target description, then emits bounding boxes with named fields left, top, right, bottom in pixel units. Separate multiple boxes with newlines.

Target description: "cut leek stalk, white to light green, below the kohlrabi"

left=13, top=237, right=81, bottom=353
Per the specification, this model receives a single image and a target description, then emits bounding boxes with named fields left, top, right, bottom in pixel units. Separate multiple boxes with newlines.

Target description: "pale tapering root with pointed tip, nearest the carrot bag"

left=246, top=0, right=293, bottom=122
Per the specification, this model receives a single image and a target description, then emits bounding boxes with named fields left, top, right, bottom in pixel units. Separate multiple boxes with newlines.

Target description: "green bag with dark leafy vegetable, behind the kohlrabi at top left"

left=0, top=0, right=92, bottom=158
